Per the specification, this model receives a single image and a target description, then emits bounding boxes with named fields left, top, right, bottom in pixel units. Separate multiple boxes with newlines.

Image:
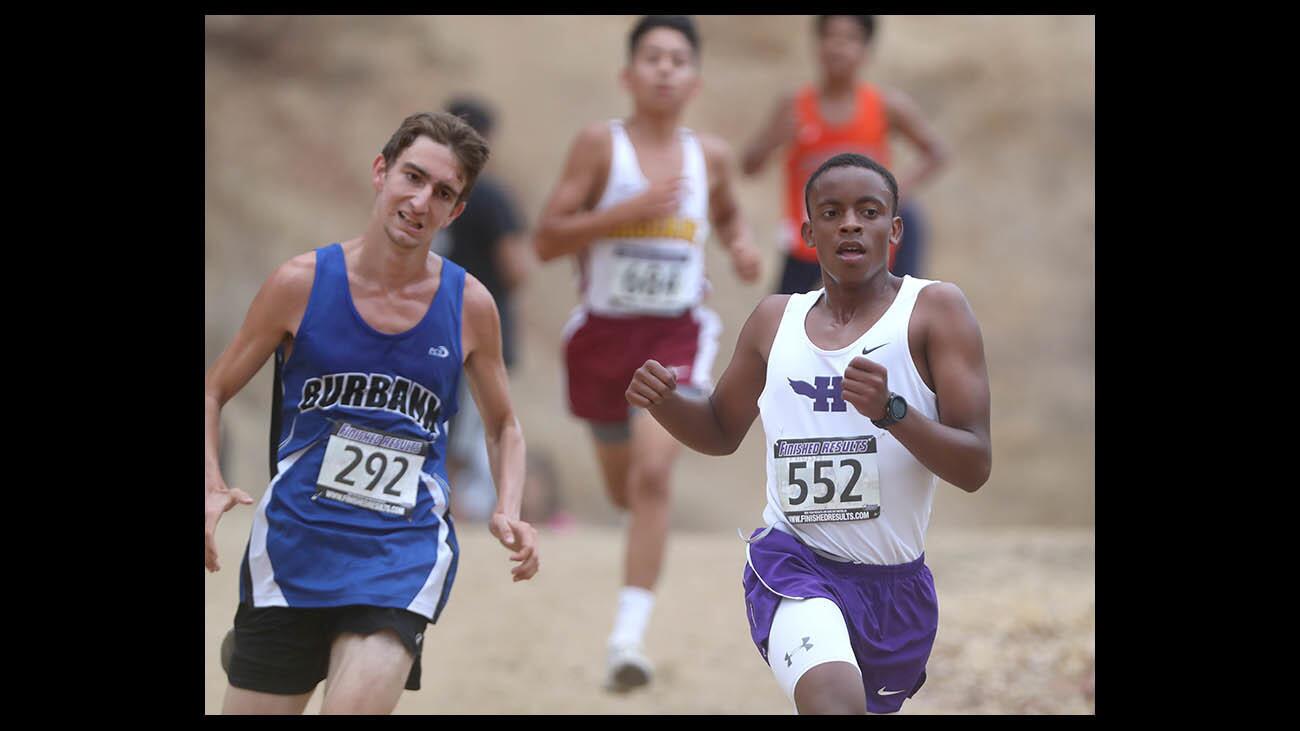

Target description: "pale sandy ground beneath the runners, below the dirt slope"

left=203, top=510, right=1096, bottom=714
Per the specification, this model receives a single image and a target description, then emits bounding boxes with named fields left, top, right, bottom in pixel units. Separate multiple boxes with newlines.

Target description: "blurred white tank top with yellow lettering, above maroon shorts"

left=579, top=120, right=709, bottom=316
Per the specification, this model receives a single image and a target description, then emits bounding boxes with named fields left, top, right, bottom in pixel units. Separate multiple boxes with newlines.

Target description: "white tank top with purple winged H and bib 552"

left=758, top=276, right=939, bottom=566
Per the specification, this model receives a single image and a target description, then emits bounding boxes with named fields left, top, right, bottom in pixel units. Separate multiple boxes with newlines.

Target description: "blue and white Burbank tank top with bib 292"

left=239, top=243, right=465, bottom=620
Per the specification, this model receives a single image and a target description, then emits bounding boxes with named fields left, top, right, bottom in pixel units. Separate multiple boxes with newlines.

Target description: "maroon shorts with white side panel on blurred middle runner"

left=564, top=307, right=722, bottom=423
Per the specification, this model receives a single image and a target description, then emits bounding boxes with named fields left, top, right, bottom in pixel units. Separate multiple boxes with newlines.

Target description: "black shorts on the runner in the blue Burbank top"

left=226, top=604, right=429, bottom=696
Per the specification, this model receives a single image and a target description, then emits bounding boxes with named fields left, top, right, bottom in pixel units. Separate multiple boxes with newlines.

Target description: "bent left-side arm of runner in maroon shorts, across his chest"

left=533, top=122, right=681, bottom=261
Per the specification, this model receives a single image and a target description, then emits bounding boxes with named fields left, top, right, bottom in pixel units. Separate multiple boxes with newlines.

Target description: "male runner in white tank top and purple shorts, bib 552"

left=627, top=153, right=992, bottom=714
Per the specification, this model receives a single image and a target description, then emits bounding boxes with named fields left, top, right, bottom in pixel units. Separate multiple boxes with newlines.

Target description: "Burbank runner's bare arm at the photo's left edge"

left=203, top=252, right=316, bottom=571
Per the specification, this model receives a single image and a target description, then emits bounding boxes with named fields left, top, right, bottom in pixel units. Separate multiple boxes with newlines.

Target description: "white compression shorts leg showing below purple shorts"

left=767, top=597, right=862, bottom=704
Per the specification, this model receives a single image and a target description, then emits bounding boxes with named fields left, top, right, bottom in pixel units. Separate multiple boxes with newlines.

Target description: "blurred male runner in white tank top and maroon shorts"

left=534, top=16, right=759, bottom=691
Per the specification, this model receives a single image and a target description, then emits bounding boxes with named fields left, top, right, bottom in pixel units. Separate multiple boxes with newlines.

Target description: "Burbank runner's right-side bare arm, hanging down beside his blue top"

left=460, top=273, right=540, bottom=581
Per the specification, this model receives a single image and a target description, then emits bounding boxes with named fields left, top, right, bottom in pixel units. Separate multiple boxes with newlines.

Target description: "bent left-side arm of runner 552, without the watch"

left=627, top=294, right=789, bottom=455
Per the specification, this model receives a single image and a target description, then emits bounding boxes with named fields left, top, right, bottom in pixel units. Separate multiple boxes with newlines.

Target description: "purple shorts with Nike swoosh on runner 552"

left=744, top=529, right=939, bottom=713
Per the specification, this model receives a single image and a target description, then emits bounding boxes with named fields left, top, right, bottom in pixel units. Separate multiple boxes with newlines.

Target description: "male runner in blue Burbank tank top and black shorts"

left=204, top=113, right=538, bottom=714
